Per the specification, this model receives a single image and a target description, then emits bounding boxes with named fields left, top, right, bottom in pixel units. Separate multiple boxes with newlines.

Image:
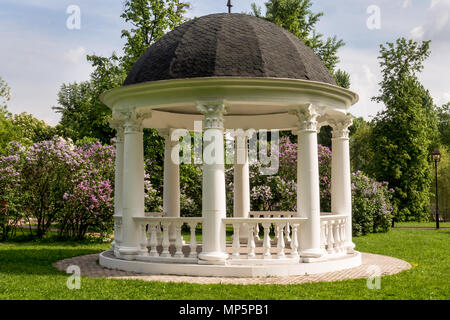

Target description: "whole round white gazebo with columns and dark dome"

left=100, top=14, right=361, bottom=277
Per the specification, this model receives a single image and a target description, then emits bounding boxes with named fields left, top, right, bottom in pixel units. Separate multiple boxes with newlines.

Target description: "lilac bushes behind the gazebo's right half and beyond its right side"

left=226, top=137, right=393, bottom=236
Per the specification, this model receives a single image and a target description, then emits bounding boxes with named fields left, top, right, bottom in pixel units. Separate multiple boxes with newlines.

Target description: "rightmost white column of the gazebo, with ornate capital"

left=328, top=115, right=355, bottom=252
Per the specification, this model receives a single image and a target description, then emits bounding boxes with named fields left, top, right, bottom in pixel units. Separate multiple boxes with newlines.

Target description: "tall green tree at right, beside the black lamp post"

left=370, top=38, right=437, bottom=221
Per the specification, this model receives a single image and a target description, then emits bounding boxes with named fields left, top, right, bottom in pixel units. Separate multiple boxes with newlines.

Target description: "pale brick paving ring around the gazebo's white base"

left=53, top=252, right=411, bottom=284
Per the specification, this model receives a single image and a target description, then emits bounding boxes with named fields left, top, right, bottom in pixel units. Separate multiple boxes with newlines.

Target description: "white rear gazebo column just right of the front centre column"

left=233, top=130, right=250, bottom=240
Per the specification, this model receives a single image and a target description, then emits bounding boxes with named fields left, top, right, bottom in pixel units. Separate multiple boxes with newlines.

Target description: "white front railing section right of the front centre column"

left=222, top=218, right=307, bottom=262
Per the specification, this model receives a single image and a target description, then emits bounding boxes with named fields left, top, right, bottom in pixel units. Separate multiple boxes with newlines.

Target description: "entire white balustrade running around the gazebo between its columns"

left=129, top=212, right=347, bottom=263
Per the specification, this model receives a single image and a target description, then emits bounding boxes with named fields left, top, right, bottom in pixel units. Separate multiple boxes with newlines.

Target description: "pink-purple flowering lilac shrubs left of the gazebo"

left=0, top=136, right=160, bottom=240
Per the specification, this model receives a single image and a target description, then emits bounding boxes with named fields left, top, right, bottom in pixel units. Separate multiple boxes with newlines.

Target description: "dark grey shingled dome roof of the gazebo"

left=124, top=13, right=336, bottom=85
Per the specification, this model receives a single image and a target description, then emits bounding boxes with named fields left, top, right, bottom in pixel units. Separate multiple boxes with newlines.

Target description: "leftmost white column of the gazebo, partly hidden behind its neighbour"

left=109, top=120, right=125, bottom=256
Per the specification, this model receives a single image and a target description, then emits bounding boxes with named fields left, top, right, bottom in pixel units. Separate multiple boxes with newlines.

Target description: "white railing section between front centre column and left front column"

left=134, top=217, right=203, bottom=263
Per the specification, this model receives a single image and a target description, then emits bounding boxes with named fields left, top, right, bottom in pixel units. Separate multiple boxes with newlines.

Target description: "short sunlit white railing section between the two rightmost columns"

left=320, top=214, right=347, bottom=255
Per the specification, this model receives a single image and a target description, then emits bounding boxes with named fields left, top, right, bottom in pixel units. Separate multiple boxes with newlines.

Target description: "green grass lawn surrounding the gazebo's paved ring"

left=0, top=229, right=450, bottom=300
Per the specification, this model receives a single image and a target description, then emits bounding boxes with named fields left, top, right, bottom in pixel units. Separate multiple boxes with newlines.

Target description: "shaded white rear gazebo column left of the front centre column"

left=158, top=129, right=180, bottom=242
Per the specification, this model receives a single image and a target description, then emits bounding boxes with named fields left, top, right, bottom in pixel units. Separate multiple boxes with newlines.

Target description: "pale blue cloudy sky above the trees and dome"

left=0, top=0, right=450, bottom=125
